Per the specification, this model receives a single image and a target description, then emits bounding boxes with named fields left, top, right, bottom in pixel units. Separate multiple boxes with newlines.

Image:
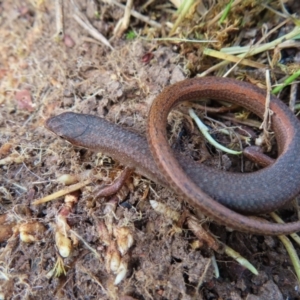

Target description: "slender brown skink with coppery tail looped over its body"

left=46, top=77, right=300, bottom=235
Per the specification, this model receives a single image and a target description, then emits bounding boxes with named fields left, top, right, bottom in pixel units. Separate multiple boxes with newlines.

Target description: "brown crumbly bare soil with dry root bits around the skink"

left=0, top=0, right=300, bottom=300
